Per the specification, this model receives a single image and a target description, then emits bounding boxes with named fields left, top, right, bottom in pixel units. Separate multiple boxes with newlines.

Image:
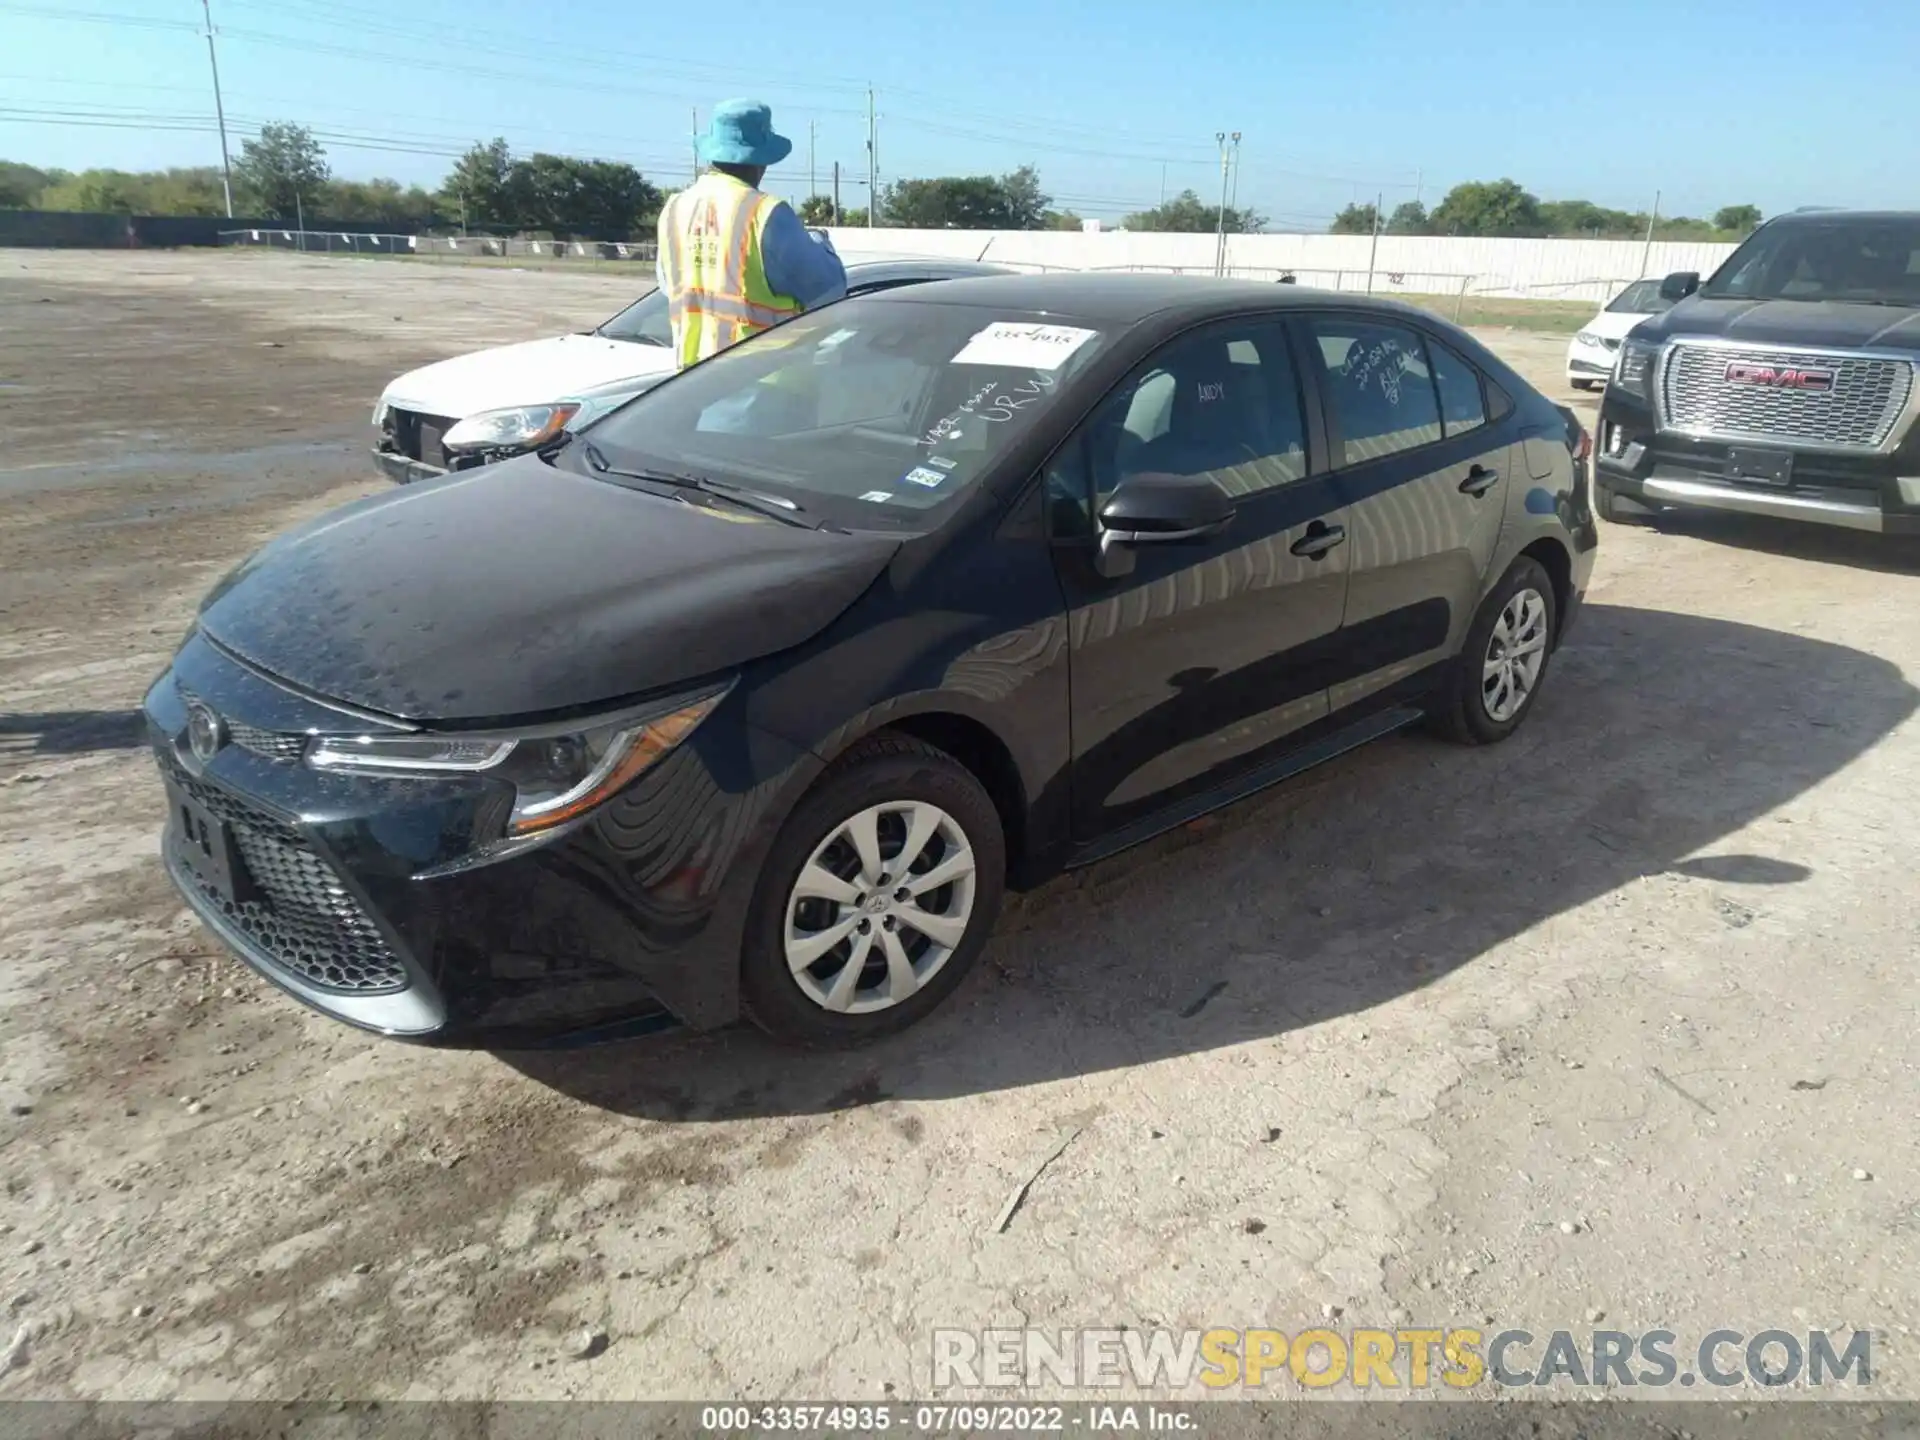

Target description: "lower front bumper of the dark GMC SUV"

left=1594, top=386, right=1920, bottom=536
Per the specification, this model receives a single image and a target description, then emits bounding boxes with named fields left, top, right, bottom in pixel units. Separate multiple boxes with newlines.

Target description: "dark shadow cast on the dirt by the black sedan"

left=499, top=605, right=1916, bottom=1121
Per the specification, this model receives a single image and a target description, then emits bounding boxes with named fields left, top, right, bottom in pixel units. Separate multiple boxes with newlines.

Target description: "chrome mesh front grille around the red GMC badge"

left=1661, top=340, right=1914, bottom=449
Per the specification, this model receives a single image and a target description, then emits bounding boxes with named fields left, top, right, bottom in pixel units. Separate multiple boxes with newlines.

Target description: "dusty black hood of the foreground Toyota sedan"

left=200, top=455, right=899, bottom=724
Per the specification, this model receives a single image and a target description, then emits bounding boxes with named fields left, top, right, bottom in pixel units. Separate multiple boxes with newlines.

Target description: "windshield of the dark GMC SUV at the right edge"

left=1699, top=217, right=1920, bottom=305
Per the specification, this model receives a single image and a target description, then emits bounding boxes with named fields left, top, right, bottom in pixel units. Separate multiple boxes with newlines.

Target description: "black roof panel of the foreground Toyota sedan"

left=856, top=271, right=1434, bottom=324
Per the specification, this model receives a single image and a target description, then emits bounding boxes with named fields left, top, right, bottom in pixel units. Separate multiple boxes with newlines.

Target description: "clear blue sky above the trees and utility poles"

left=0, top=0, right=1920, bottom=228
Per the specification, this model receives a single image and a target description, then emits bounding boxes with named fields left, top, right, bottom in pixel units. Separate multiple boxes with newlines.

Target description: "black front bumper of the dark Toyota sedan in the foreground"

left=146, top=636, right=820, bottom=1046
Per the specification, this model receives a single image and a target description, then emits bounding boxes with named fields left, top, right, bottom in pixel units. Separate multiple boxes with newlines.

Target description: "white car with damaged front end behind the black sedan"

left=372, top=259, right=1006, bottom=484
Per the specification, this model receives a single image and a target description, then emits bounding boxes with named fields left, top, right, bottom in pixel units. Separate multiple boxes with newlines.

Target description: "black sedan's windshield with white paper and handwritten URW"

left=588, top=296, right=1106, bottom=528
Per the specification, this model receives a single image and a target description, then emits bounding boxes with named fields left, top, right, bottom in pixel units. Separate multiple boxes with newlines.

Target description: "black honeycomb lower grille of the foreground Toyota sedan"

left=159, top=755, right=407, bottom=995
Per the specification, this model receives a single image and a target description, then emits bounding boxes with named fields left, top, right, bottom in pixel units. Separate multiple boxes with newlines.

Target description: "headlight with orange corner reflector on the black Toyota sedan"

left=307, top=689, right=726, bottom=837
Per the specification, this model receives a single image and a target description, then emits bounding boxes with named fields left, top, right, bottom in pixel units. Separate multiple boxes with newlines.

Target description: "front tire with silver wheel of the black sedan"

left=741, top=732, right=1006, bottom=1046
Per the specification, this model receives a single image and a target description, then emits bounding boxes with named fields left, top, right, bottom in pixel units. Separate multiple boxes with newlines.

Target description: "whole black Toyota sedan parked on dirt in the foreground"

left=146, top=275, right=1594, bottom=1046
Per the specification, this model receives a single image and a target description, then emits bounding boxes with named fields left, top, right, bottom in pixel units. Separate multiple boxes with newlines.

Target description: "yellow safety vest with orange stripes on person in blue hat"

left=660, top=173, right=804, bottom=371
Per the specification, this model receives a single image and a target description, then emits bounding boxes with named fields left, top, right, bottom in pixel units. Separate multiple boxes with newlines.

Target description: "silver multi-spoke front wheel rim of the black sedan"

left=783, top=801, right=977, bottom=1016
